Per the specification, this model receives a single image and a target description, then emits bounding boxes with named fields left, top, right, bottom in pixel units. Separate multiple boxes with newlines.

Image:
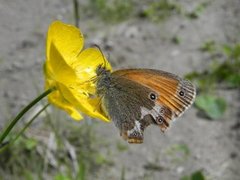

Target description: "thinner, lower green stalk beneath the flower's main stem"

left=0, top=104, right=49, bottom=153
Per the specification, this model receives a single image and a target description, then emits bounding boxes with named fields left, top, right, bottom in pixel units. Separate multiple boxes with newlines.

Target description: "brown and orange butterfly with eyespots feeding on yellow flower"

left=96, top=65, right=196, bottom=143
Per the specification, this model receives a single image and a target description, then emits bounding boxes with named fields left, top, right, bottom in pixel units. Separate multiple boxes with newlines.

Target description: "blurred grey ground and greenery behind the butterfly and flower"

left=0, top=0, right=240, bottom=180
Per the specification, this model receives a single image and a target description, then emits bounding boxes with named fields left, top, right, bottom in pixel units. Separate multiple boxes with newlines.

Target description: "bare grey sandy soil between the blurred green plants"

left=0, top=0, right=240, bottom=180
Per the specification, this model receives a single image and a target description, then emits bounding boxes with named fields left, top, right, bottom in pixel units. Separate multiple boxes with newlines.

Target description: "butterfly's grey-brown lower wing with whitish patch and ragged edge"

left=97, top=74, right=158, bottom=143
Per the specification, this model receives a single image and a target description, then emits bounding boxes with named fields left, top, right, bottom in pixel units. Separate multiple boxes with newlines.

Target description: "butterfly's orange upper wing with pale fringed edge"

left=112, top=69, right=196, bottom=131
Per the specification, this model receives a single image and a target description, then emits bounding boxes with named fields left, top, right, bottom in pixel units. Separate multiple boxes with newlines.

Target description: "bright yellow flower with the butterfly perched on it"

left=44, top=21, right=111, bottom=121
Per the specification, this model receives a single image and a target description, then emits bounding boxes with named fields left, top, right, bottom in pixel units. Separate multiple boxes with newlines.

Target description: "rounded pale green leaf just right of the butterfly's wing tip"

left=195, top=95, right=227, bottom=119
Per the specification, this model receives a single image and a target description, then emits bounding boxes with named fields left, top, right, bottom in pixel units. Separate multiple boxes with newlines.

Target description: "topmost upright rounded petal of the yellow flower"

left=46, top=21, right=84, bottom=64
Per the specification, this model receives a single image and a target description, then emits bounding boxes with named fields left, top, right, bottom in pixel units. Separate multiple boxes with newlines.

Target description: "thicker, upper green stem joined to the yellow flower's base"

left=0, top=88, right=55, bottom=144
